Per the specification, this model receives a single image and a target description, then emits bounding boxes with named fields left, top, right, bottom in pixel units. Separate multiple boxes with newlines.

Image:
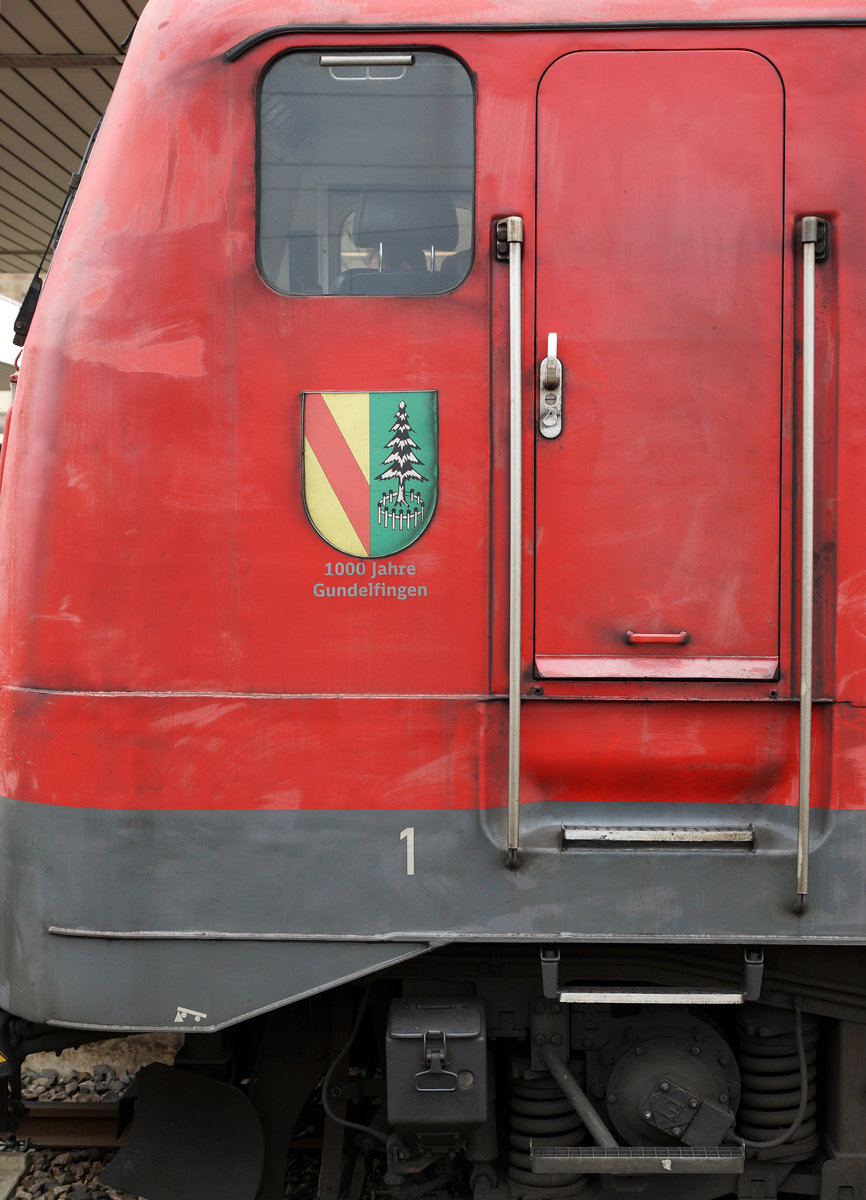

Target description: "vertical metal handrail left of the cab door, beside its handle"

left=498, top=217, right=523, bottom=868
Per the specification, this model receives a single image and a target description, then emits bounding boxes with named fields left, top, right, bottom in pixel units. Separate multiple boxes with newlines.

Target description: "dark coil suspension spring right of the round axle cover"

left=738, top=1007, right=818, bottom=1163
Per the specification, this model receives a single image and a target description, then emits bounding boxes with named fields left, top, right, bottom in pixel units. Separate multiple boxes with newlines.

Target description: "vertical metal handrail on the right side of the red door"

left=794, top=217, right=818, bottom=913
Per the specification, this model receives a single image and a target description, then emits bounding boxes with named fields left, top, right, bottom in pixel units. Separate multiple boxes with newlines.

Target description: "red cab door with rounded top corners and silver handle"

left=535, top=49, right=784, bottom=679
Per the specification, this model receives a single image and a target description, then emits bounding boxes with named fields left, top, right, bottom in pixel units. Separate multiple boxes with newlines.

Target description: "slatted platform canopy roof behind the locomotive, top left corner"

left=0, top=0, right=146, bottom=274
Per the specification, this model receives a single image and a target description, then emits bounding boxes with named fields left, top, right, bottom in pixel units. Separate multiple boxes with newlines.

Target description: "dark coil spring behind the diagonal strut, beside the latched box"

left=509, top=1063, right=589, bottom=1200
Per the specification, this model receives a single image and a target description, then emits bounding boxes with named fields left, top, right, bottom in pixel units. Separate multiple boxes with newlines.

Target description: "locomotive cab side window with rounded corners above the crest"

left=258, top=50, right=475, bottom=295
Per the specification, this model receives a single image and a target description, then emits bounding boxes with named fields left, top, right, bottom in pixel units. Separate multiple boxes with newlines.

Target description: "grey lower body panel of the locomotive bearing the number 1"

left=0, top=799, right=866, bottom=1030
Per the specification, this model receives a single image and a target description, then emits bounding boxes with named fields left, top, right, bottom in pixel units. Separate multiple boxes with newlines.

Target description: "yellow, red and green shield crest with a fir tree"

left=303, top=391, right=438, bottom=558
